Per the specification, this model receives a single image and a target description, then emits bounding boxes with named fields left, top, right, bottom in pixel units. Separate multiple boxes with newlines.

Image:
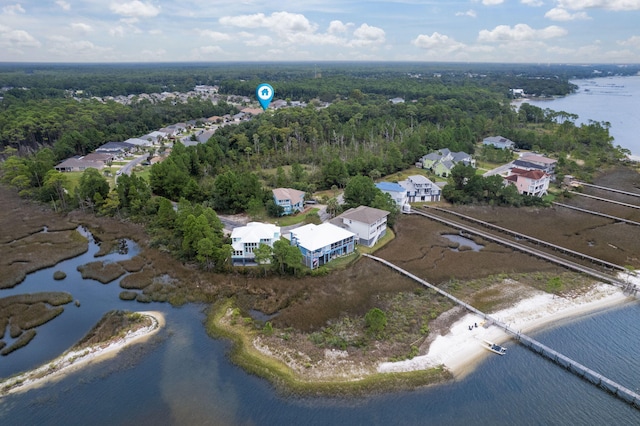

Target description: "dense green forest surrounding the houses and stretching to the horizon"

left=0, top=63, right=638, bottom=270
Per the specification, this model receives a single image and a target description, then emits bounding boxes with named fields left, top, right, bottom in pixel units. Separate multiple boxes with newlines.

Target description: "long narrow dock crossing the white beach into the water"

left=364, top=254, right=640, bottom=409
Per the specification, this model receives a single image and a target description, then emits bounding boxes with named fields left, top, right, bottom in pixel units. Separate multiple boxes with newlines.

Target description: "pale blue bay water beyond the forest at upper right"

left=526, top=76, right=640, bottom=155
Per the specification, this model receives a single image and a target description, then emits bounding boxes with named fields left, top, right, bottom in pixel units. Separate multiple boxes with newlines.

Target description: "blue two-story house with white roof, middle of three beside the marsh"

left=291, top=222, right=356, bottom=269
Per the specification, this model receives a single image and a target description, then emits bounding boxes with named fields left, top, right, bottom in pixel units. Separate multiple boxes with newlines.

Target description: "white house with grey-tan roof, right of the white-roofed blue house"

left=331, top=206, right=389, bottom=247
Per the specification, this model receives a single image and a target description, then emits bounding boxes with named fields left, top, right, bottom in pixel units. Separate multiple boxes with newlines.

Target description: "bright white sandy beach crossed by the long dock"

left=378, top=278, right=637, bottom=379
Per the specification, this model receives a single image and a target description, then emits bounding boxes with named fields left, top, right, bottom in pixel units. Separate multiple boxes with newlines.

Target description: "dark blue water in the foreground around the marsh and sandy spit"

left=0, top=230, right=640, bottom=426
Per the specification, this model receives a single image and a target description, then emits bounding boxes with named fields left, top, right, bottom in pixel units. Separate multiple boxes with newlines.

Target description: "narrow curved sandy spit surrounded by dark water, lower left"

left=0, top=311, right=165, bottom=397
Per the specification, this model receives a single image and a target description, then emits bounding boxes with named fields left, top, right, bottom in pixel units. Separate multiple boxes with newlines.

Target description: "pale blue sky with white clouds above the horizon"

left=0, top=0, right=640, bottom=63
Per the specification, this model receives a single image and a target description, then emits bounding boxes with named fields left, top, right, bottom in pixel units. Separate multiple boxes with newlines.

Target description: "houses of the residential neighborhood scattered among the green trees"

left=50, top=86, right=556, bottom=269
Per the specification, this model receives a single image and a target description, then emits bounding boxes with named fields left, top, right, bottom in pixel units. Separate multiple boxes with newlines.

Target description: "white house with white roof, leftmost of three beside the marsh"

left=231, top=222, right=280, bottom=265
